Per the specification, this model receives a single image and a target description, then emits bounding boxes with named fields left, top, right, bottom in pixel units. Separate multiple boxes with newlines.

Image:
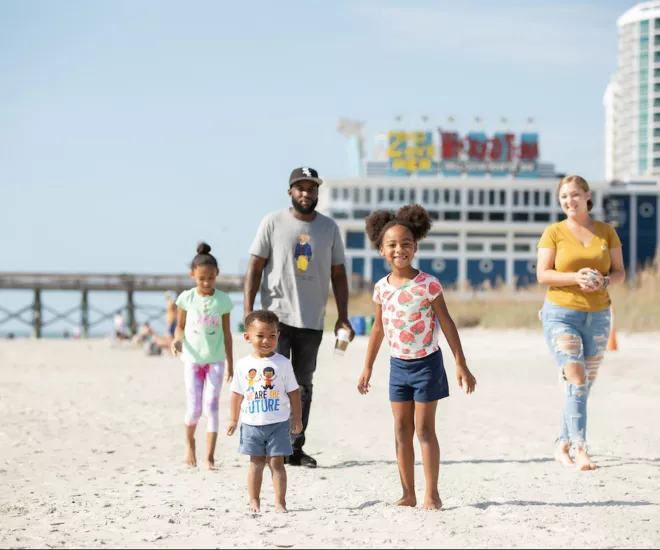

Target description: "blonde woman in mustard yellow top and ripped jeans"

left=536, top=176, right=626, bottom=470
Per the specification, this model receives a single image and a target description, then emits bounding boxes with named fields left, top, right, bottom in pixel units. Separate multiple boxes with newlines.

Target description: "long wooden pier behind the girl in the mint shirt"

left=0, top=272, right=244, bottom=338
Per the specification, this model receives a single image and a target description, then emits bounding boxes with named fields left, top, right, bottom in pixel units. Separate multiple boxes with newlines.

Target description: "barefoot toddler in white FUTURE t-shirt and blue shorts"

left=227, top=310, right=302, bottom=513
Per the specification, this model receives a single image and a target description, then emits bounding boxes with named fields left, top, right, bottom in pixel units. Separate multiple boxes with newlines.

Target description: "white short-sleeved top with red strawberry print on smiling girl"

left=374, top=271, right=442, bottom=359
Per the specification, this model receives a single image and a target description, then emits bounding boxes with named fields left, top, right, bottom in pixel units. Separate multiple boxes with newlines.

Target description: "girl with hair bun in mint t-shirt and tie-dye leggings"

left=172, top=243, right=234, bottom=470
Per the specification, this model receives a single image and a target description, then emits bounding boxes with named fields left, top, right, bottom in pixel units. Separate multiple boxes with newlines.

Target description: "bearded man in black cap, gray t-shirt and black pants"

left=244, top=167, right=355, bottom=468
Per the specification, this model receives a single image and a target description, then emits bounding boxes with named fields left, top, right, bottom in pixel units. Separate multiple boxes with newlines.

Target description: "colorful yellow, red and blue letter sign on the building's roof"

left=387, top=129, right=539, bottom=178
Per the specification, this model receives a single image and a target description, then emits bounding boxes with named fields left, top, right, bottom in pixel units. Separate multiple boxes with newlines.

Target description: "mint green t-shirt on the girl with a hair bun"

left=176, top=288, right=234, bottom=365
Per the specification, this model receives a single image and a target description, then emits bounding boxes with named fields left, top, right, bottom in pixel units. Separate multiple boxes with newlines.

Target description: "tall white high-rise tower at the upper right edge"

left=603, top=1, right=660, bottom=180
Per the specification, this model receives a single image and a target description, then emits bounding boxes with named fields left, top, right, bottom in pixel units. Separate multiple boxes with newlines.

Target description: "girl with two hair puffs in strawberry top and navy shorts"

left=358, top=205, right=477, bottom=510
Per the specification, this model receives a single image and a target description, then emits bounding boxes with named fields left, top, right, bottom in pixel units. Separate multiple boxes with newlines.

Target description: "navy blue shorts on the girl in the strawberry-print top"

left=390, top=350, right=449, bottom=403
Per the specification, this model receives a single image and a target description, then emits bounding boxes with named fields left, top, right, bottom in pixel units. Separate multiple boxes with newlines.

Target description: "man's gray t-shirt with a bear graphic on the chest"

left=250, top=209, right=345, bottom=330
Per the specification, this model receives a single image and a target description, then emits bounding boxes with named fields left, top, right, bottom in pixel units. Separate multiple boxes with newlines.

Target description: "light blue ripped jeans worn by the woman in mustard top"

left=540, top=300, right=610, bottom=449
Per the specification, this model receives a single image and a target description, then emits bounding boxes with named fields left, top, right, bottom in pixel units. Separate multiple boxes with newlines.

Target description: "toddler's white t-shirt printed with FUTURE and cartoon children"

left=231, top=353, right=299, bottom=426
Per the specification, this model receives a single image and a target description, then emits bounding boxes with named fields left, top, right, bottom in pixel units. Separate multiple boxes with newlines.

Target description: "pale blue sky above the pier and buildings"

left=0, top=0, right=633, bottom=280
